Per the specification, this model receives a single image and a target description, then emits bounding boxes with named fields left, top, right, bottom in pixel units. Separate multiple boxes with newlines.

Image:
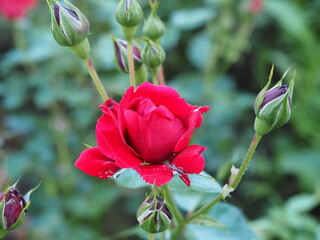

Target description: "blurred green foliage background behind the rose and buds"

left=0, top=0, right=320, bottom=240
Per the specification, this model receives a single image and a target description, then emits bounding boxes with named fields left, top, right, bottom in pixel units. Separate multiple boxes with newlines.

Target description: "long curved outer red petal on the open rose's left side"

left=96, top=113, right=141, bottom=168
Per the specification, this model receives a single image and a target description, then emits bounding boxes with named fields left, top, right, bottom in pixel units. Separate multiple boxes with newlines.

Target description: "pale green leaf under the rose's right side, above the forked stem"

left=168, top=172, right=222, bottom=193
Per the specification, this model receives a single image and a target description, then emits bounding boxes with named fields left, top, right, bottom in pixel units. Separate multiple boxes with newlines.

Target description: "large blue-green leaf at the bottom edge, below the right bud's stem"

left=185, top=203, right=257, bottom=240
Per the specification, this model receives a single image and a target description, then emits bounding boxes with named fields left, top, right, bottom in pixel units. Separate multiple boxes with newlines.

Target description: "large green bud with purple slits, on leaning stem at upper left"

left=47, top=0, right=90, bottom=59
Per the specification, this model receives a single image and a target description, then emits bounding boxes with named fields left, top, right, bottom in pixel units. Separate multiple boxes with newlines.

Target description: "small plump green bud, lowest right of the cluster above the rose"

left=141, top=40, right=166, bottom=71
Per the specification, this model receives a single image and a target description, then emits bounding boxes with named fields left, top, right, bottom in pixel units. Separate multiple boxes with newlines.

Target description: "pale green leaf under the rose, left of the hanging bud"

left=114, top=169, right=148, bottom=188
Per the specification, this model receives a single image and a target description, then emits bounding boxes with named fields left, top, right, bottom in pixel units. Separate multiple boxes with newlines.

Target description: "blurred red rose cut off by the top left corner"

left=0, top=0, right=37, bottom=20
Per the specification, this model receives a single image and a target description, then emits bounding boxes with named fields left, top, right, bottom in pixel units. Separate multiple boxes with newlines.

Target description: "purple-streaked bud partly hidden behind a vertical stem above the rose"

left=112, top=37, right=142, bottom=73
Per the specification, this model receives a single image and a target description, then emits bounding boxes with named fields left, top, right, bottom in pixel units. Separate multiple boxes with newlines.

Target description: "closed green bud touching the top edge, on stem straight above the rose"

left=115, top=0, right=143, bottom=40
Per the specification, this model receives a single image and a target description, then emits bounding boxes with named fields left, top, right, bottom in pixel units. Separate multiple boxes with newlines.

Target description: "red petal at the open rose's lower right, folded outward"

left=172, top=145, right=206, bottom=174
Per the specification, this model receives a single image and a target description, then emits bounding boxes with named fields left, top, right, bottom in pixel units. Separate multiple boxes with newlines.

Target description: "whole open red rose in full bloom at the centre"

left=75, top=82, right=210, bottom=186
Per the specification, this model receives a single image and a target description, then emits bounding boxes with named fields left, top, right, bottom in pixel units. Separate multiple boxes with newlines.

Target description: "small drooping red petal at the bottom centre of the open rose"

left=136, top=164, right=173, bottom=186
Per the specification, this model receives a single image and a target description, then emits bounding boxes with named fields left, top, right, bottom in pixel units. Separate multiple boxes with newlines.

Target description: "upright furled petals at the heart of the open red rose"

left=124, top=106, right=185, bottom=163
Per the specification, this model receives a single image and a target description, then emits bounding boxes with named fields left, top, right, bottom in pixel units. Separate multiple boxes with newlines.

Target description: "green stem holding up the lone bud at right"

left=171, top=134, right=262, bottom=240
